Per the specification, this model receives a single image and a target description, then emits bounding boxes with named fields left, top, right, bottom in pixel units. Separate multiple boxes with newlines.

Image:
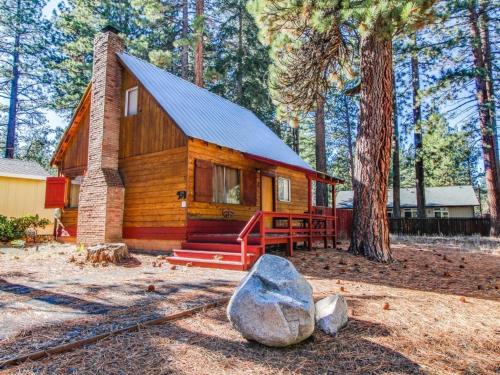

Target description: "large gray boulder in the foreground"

left=227, top=255, right=314, bottom=347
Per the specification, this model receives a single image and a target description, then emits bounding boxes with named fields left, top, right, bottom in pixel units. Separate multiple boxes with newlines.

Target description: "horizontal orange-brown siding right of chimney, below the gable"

left=119, top=147, right=187, bottom=228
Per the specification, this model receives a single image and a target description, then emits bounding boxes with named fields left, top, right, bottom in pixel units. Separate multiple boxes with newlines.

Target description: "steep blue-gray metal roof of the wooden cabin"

left=118, top=53, right=312, bottom=170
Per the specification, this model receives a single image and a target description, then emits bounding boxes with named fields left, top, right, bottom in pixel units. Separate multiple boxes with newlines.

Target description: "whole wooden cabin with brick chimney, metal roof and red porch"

left=46, top=27, right=341, bottom=270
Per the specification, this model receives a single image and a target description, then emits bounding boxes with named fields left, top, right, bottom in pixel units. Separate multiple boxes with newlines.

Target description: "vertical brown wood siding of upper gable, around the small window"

left=120, top=69, right=187, bottom=159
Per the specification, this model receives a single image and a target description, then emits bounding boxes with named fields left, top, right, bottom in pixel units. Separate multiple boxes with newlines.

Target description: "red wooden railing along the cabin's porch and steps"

left=238, top=209, right=336, bottom=265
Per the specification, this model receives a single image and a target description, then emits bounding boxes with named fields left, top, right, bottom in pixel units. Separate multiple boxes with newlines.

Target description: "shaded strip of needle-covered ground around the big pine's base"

left=274, top=245, right=500, bottom=300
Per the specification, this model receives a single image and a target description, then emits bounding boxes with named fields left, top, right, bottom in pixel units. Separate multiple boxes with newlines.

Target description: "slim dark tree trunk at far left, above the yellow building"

left=5, top=0, right=21, bottom=159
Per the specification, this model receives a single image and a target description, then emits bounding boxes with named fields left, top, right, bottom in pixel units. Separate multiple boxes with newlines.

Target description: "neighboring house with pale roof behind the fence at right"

left=336, top=185, right=479, bottom=218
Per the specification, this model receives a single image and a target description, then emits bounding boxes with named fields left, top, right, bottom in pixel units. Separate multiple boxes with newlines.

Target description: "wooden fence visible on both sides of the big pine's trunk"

left=336, top=209, right=491, bottom=240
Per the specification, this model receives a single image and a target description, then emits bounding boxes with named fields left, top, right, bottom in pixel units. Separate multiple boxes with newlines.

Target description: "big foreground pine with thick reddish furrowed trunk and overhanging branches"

left=252, top=0, right=433, bottom=261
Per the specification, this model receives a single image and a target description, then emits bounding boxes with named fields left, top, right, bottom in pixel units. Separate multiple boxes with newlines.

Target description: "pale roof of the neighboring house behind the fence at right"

left=335, top=185, right=479, bottom=208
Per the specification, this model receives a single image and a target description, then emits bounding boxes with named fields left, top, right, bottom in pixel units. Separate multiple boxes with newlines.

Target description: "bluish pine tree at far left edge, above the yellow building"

left=0, top=0, right=51, bottom=158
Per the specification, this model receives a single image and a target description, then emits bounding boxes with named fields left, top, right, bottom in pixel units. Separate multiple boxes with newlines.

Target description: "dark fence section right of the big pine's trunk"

left=389, top=217, right=491, bottom=236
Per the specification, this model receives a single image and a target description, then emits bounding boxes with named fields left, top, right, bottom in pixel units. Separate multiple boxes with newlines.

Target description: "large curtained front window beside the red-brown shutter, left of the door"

left=212, top=165, right=240, bottom=204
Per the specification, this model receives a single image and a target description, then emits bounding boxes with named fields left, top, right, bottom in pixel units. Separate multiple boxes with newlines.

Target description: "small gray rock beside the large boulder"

left=315, top=295, right=347, bottom=335
